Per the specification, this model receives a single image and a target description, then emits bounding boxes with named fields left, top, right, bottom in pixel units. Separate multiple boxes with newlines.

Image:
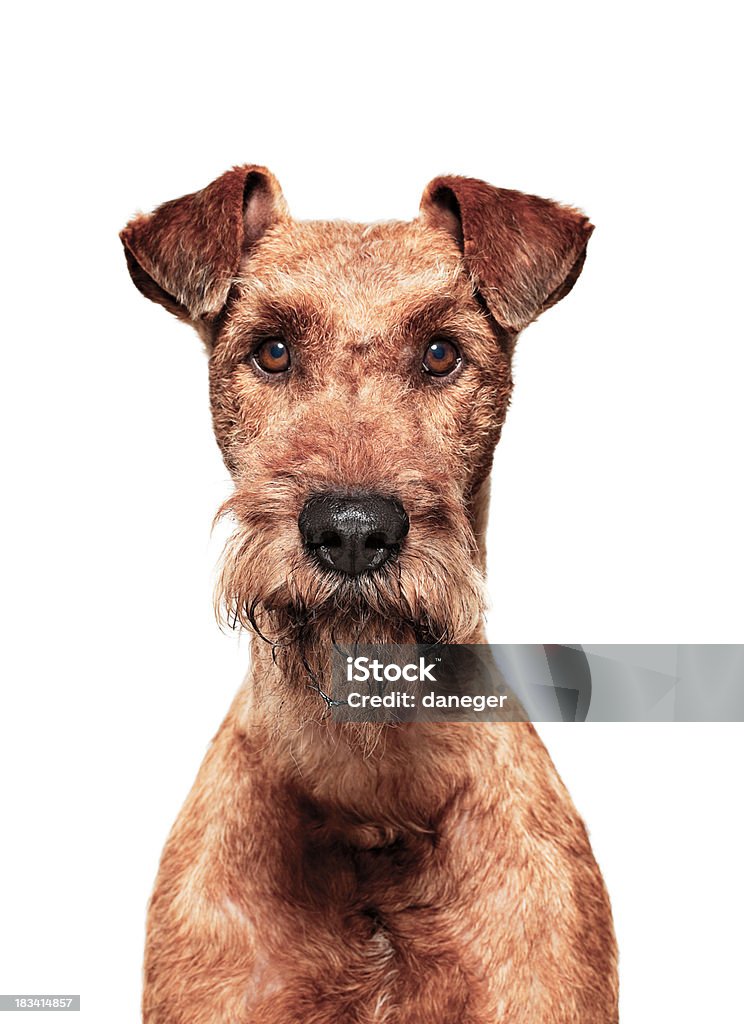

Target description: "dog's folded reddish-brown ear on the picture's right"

left=421, top=177, right=594, bottom=332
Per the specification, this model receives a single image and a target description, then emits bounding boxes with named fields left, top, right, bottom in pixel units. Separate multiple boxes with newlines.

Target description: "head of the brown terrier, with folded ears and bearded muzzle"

left=122, top=166, right=592, bottom=642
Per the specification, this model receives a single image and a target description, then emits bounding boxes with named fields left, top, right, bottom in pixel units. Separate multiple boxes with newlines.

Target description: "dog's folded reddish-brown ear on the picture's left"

left=120, top=165, right=288, bottom=324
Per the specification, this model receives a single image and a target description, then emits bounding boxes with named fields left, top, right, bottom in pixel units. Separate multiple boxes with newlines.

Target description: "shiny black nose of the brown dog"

left=299, top=495, right=408, bottom=575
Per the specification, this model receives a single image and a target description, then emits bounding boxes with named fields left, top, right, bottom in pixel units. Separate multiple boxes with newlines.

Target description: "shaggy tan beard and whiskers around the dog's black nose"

left=216, top=496, right=484, bottom=648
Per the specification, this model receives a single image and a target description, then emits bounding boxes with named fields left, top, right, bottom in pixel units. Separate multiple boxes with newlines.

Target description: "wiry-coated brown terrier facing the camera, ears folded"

left=122, top=166, right=617, bottom=1024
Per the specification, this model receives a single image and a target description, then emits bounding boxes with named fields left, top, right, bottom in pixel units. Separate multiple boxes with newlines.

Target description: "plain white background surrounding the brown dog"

left=0, top=0, right=744, bottom=1024
